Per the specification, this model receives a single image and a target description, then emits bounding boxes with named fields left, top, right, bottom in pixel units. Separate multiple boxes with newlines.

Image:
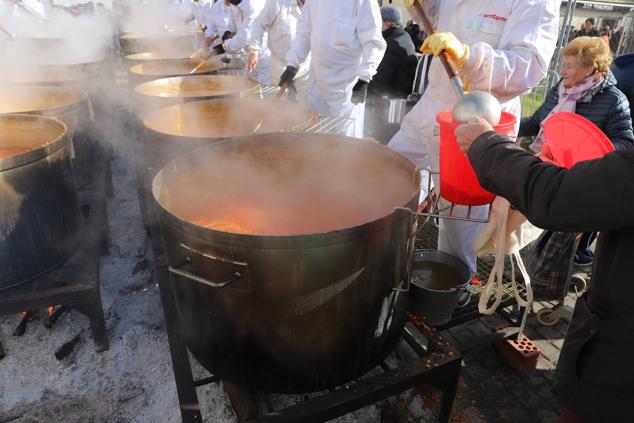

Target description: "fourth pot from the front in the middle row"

left=128, top=58, right=225, bottom=87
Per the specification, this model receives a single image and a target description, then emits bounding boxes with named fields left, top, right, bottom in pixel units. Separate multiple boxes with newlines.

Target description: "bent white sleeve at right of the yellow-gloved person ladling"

left=463, top=0, right=560, bottom=101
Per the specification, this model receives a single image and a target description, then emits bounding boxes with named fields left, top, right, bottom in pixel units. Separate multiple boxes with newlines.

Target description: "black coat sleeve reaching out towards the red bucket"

left=468, top=131, right=634, bottom=232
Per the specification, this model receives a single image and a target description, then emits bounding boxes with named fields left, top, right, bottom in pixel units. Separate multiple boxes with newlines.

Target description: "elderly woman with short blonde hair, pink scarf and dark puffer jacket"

left=518, top=37, right=634, bottom=265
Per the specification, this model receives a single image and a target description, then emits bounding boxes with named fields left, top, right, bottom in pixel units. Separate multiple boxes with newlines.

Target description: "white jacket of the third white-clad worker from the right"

left=248, top=0, right=302, bottom=62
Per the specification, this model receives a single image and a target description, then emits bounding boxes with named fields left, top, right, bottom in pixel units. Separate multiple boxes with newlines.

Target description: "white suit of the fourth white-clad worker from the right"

left=222, top=0, right=271, bottom=86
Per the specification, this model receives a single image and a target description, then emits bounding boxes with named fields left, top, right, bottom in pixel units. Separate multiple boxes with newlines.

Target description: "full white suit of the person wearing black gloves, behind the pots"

left=286, top=0, right=386, bottom=138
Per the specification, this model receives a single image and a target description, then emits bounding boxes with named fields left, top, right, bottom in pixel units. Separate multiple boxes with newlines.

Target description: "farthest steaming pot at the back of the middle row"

left=119, top=31, right=203, bottom=55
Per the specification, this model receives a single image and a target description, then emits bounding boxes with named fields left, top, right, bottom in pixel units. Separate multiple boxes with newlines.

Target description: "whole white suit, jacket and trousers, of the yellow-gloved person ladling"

left=388, top=0, right=561, bottom=273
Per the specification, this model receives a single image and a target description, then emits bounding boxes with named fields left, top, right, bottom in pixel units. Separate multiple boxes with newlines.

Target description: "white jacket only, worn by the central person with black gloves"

left=286, top=0, right=386, bottom=83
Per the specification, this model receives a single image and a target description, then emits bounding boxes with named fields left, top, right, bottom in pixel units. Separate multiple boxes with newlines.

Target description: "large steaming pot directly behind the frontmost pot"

left=143, top=98, right=312, bottom=174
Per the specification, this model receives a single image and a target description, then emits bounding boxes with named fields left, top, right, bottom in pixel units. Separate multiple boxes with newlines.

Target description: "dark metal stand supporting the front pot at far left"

left=0, top=146, right=110, bottom=352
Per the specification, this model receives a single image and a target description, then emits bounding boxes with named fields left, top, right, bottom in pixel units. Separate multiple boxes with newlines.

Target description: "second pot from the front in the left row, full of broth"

left=0, top=85, right=95, bottom=185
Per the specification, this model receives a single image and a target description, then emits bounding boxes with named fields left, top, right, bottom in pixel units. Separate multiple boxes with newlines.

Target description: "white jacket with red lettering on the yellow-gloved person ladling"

left=401, top=0, right=561, bottom=139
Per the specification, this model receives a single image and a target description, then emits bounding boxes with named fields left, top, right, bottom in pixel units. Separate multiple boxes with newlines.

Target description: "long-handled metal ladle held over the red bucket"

left=412, top=0, right=502, bottom=125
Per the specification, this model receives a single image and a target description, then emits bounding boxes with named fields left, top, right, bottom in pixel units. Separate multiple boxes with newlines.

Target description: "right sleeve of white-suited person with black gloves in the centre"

left=356, top=0, right=387, bottom=82
